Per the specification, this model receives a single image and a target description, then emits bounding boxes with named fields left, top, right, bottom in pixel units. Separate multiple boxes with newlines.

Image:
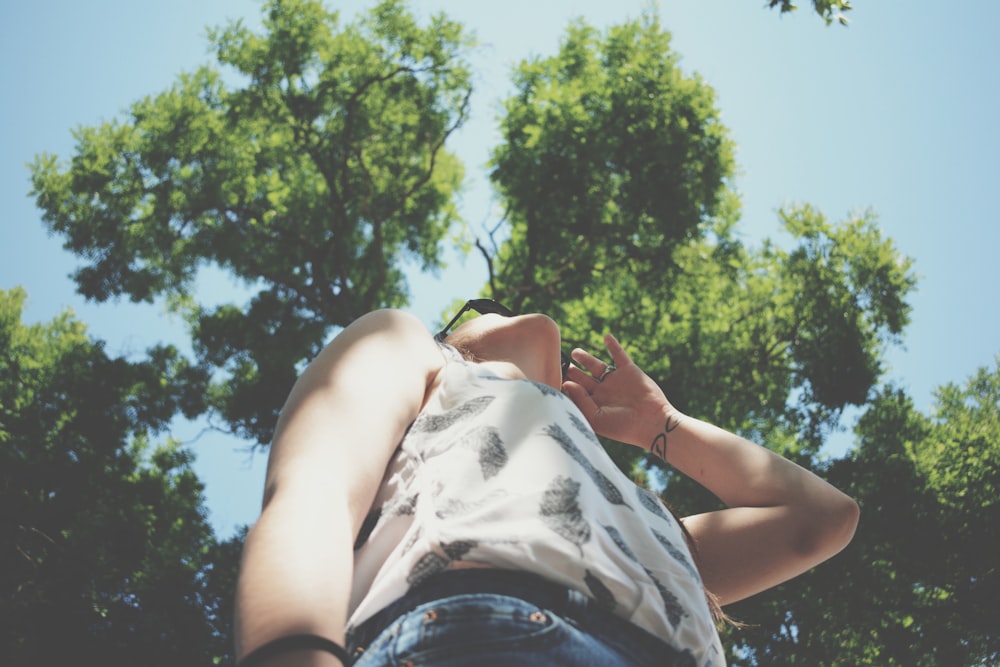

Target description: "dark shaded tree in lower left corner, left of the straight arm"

left=0, top=290, right=239, bottom=666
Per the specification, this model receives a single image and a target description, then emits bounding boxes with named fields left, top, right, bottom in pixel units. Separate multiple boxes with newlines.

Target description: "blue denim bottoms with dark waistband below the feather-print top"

left=347, top=569, right=695, bottom=667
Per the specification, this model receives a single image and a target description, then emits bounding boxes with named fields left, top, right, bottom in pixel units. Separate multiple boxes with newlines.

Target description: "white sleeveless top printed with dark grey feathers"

left=348, top=345, right=725, bottom=667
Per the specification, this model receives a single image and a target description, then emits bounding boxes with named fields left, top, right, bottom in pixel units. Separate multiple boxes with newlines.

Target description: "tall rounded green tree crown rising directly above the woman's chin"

left=491, top=11, right=733, bottom=315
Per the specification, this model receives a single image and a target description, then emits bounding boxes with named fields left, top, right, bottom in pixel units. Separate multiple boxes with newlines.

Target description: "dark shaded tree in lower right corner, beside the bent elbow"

left=732, top=361, right=1000, bottom=667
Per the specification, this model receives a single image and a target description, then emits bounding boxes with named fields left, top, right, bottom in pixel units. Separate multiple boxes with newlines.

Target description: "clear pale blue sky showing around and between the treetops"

left=0, top=0, right=1000, bottom=536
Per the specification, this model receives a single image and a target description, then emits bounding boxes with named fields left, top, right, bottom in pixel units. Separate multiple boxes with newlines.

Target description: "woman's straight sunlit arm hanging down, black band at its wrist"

left=236, top=310, right=443, bottom=665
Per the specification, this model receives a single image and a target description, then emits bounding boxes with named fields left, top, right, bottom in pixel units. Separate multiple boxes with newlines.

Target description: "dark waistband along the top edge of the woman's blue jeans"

left=347, top=568, right=680, bottom=664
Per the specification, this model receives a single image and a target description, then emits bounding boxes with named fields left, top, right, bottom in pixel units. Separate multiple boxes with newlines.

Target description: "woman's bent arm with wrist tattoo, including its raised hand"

left=564, top=336, right=858, bottom=604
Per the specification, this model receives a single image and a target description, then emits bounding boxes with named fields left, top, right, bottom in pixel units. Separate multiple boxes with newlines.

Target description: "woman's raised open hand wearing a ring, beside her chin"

left=562, top=334, right=680, bottom=449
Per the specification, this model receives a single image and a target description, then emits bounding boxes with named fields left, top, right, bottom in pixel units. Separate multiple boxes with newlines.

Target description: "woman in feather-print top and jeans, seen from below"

left=237, top=300, right=858, bottom=667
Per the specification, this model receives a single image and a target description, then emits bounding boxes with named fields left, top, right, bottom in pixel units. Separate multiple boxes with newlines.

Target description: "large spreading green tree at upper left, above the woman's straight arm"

left=31, top=0, right=471, bottom=443
